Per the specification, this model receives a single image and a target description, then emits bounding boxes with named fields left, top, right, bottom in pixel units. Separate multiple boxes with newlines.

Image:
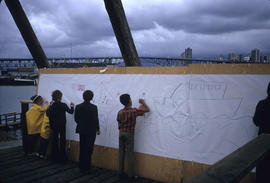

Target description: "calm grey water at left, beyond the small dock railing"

left=0, top=86, right=36, bottom=114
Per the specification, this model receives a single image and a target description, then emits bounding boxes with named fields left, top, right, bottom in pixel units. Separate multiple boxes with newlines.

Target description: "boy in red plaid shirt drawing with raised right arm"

left=117, top=94, right=150, bottom=179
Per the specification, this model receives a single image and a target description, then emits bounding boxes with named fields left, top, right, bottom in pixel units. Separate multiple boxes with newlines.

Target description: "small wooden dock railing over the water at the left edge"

left=0, top=112, right=21, bottom=131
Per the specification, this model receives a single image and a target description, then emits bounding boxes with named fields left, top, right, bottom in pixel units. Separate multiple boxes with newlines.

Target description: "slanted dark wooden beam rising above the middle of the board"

left=104, top=0, right=141, bottom=66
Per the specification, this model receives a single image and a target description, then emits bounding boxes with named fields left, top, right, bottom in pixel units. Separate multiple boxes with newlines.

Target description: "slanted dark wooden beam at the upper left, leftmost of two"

left=5, top=0, right=48, bottom=68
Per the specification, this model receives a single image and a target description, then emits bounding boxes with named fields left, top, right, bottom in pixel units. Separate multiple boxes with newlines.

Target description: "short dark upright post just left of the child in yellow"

left=21, top=100, right=32, bottom=154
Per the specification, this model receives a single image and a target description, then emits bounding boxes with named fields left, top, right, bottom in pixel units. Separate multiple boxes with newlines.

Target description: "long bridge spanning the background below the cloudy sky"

left=0, top=57, right=255, bottom=69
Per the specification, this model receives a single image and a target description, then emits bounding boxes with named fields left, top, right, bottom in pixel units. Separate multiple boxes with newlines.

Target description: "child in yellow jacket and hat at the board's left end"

left=26, top=95, right=48, bottom=155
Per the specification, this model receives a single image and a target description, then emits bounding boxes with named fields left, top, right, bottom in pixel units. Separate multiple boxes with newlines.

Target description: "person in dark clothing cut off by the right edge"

left=253, top=82, right=270, bottom=183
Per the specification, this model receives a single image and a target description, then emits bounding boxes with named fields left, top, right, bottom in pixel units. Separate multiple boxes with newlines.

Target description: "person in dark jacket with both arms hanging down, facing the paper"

left=74, top=90, right=100, bottom=172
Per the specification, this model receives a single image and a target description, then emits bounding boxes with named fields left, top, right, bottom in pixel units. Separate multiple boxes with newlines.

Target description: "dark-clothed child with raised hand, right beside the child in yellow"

left=47, top=90, right=74, bottom=163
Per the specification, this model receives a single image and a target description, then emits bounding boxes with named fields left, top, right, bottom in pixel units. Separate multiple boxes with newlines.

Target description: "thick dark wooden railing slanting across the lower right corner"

left=185, top=134, right=270, bottom=183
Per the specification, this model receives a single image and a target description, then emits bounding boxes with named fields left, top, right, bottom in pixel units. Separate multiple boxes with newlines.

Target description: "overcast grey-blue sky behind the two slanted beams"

left=0, top=0, right=270, bottom=58
